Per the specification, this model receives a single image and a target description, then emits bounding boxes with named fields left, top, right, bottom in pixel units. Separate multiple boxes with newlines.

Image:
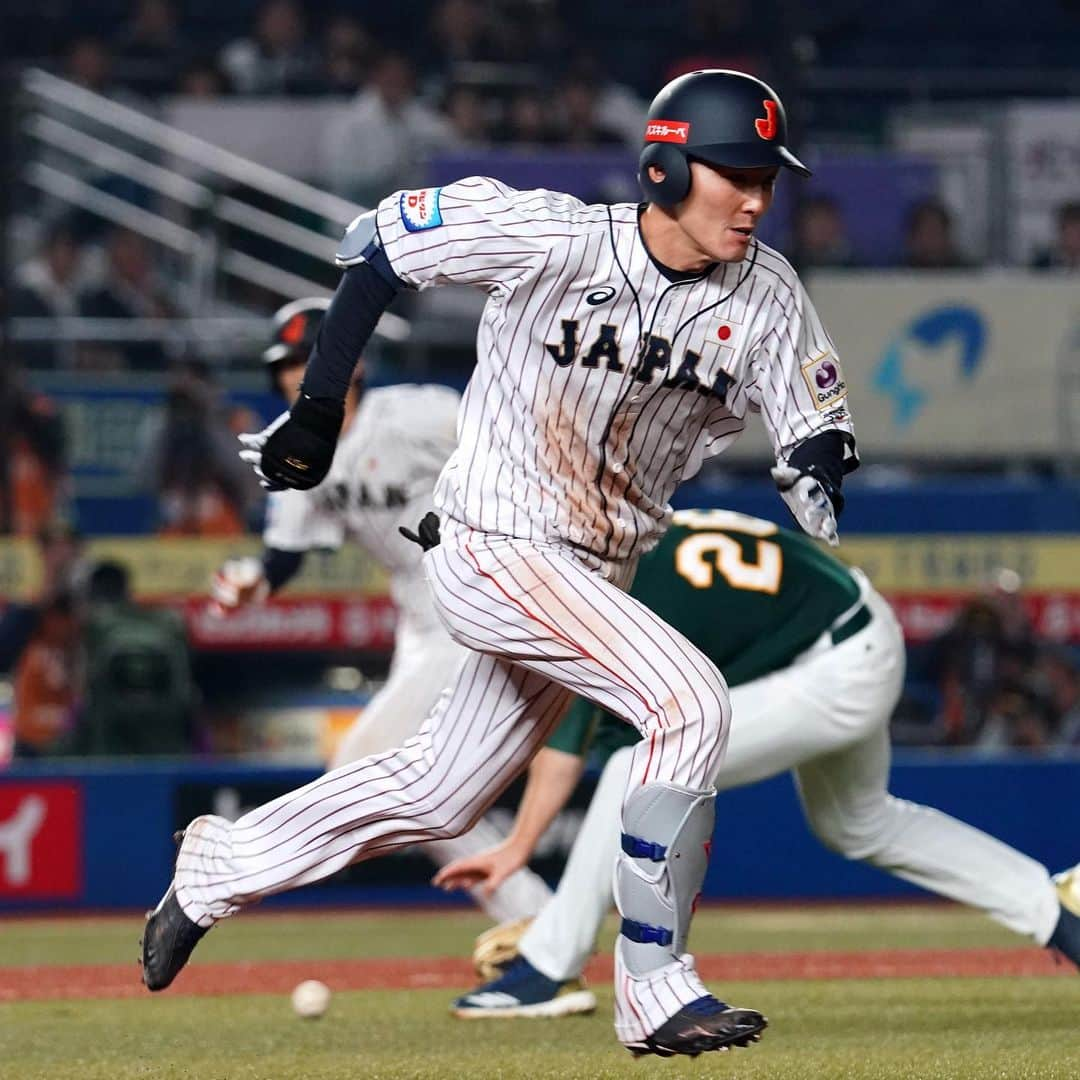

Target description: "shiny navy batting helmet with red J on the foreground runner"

left=637, top=68, right=810, bottom=206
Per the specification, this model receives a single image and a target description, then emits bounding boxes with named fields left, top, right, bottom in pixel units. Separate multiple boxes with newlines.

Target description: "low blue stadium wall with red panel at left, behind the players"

left=0, top=754, right=1080, bottom=912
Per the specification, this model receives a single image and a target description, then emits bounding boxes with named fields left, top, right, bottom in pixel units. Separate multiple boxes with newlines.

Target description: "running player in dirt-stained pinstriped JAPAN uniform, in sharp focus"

left=143, top=70, right=858, bottom=1056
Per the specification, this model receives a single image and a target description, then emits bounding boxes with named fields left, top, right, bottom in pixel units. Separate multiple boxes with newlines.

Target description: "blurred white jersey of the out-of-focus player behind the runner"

left=262, top=383, right=460, bottom=629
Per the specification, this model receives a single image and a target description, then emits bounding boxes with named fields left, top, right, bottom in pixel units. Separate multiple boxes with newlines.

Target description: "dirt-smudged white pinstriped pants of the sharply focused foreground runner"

left=175, top=523, right=730, bottom=1041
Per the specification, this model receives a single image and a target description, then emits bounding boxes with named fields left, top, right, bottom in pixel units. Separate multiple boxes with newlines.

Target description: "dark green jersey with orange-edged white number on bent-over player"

left=548, top=510, right=859, bottom=754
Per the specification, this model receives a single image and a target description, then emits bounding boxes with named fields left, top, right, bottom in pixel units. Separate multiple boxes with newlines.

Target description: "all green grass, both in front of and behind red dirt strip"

left=0, top=906, right=1080, bottom=1080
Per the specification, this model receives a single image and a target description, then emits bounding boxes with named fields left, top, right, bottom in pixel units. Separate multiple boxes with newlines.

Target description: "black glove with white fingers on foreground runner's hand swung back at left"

left=240, top=393, right=345, bottom=491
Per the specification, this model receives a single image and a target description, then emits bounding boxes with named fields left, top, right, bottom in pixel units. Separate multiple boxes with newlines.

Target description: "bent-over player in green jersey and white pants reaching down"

left=436, top=510, right=1080, bottom=1018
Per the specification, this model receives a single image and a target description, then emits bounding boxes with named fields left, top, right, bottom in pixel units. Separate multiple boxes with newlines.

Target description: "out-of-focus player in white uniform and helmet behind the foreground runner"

left=212, top=297, right=551, bottom=922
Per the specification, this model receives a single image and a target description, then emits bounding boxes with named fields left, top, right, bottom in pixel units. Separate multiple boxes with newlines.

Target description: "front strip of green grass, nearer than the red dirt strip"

left=0, top=978, right=1080, bottom=1080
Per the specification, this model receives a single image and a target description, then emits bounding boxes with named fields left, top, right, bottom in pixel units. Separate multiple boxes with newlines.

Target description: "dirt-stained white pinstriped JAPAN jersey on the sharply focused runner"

left=377, top=177, right=851, bottom=559
